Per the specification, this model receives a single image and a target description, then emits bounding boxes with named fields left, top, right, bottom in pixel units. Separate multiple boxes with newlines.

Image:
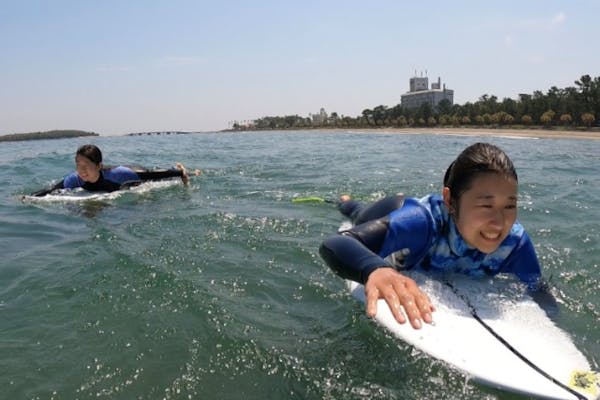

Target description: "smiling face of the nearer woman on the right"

left=443, top=173, right=517, bottom=254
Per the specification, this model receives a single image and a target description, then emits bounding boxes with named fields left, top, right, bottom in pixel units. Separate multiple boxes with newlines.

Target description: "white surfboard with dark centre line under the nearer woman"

left=346, top=271, right=600, bottom=399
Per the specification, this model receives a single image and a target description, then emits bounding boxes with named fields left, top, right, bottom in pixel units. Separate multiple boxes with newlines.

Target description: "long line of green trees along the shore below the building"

left=237, top=75, right=600, bottom=130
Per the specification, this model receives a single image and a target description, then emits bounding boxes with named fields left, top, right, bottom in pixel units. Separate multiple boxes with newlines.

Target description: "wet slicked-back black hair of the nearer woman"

left=444, top=143, right=519, bottom=212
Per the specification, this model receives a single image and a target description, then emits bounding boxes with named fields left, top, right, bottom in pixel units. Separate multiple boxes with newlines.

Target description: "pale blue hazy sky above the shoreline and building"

left=0, top=0, right=600, bottom=135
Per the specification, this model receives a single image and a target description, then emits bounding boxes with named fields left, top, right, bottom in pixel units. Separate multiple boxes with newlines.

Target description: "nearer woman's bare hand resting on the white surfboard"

left=365, top=267, right=435, bottom=329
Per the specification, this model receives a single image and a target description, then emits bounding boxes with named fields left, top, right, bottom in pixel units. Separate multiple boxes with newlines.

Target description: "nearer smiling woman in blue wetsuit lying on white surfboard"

left=319, top=143, right=555, bottom=329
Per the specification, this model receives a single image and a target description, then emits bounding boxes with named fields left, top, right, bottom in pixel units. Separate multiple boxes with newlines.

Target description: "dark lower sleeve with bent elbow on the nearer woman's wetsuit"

left=319, top=217, right=392, bottom=284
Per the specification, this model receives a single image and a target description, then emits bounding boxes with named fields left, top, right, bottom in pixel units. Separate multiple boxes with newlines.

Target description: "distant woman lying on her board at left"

left=32, top=144, right=200, bottom=197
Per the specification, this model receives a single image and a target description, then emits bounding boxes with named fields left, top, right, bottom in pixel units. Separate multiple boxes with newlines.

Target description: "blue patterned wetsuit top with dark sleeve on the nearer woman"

left=320, top=195, right=541, bottom=289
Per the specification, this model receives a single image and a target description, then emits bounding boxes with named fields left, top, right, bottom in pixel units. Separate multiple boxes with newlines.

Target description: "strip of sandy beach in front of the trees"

left=350, top=128, right=600, bottom=140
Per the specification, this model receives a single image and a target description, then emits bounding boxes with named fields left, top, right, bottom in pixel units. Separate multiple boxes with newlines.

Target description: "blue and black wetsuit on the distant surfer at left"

left=32, top=166, right=183, bottom=197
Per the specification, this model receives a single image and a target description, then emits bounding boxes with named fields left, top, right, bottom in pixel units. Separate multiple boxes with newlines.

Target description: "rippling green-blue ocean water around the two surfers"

left=0, top=131, right=600, bottom=399
